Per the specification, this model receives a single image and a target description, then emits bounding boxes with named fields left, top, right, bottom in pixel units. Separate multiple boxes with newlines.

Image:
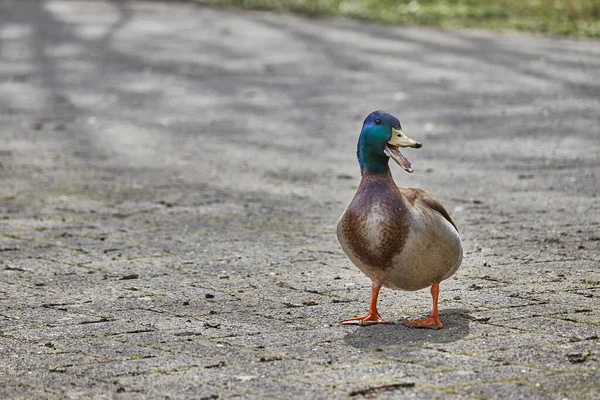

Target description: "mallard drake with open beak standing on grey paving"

left=337, top=111, right=463, bottom=329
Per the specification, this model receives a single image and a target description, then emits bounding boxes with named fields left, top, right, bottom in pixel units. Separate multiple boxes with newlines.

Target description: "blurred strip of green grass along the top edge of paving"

left=194, top=0, right=600, bottom=38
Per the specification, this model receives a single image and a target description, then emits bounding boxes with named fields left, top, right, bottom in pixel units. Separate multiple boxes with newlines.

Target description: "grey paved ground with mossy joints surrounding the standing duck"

left=0, top=0, right=600, bottom=399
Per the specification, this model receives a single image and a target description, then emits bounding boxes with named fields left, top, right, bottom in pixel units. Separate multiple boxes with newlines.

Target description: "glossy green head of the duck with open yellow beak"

left=357, top=111, right=422, bottom=172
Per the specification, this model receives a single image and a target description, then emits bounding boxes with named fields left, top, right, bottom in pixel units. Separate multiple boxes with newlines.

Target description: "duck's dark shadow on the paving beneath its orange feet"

left=344, top=309, right=470, bottom=349
